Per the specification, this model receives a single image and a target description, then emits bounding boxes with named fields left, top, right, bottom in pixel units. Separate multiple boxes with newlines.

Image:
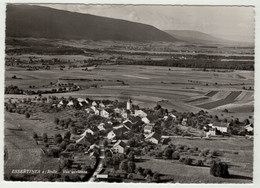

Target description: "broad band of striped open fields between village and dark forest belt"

left=5, top=62, right=254, bottom=117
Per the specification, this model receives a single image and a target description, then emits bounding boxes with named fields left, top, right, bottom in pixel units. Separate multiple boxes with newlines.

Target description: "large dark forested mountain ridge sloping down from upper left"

left=6, top=4, right=177, bottom=42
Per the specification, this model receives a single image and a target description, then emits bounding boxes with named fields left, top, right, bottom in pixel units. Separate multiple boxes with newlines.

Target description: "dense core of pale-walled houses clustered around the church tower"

left=64, top=98, right=166, bottom=153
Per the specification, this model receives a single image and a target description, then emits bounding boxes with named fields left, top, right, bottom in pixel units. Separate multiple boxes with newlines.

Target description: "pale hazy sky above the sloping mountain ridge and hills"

left=36, top=4, right=254, bottom=42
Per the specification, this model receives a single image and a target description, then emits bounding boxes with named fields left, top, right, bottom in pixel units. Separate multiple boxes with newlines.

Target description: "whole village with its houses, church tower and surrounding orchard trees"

left=5, top=95, right=253, bottom=182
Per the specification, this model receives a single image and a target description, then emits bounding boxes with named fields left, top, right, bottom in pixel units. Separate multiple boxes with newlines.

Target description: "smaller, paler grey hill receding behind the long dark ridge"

left=165, top=30, right=228, bottom=43
